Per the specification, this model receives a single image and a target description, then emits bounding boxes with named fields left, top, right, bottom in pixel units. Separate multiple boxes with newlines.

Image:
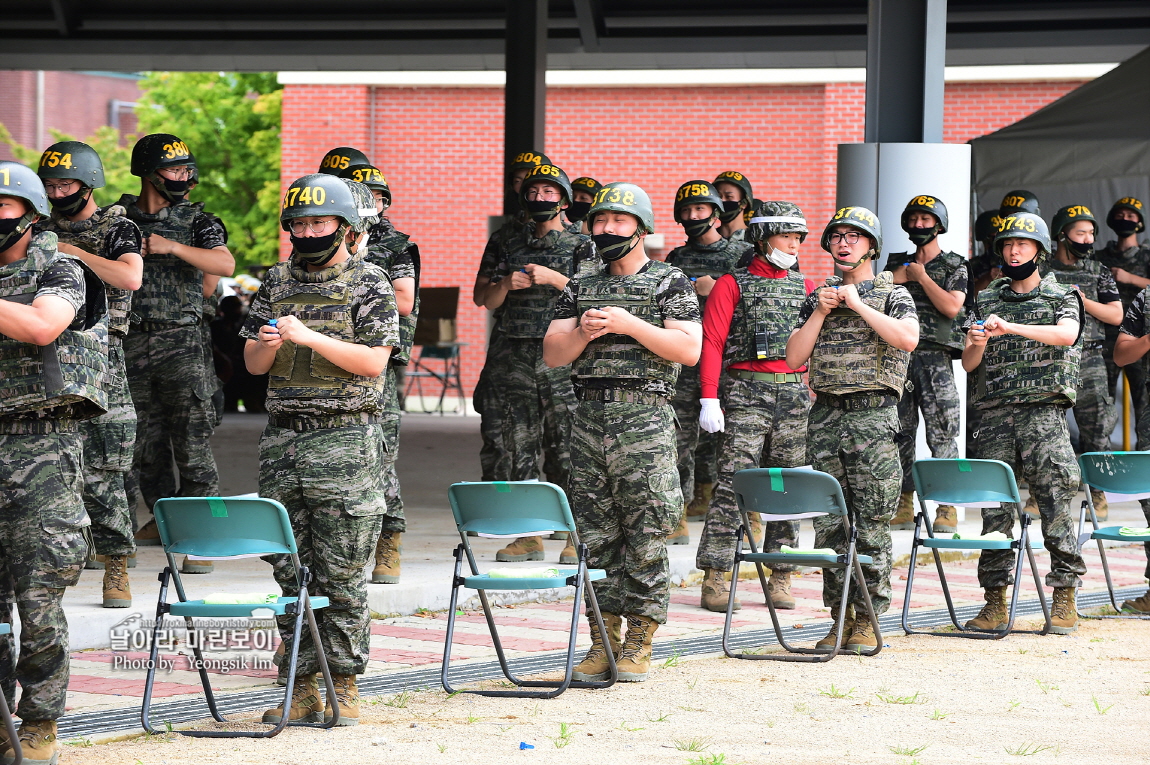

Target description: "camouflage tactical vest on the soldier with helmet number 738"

left=572, top=260, right=681, bottom=388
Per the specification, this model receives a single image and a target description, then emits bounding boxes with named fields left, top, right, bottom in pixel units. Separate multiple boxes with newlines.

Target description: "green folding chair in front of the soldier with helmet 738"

left=440, top=481, right=619, bottom=698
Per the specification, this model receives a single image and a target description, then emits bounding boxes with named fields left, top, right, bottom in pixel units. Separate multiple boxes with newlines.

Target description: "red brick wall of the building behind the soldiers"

left=283, top=82, right=1081, bottom=390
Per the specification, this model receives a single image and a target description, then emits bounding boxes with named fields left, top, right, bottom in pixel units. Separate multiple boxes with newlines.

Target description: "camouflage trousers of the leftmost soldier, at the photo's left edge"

left=0, top=432, right=87, bottom=720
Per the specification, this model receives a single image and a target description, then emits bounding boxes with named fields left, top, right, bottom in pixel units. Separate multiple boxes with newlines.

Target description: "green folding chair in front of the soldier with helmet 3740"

left=140, top=497, right=339, bottom=739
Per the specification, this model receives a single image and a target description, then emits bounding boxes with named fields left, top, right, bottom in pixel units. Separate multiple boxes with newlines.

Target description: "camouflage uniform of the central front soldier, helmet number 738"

left=554, top=261, right=699, bottom=624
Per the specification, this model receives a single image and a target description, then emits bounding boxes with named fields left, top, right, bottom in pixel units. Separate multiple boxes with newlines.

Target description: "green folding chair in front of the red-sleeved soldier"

left=722, top=467, right=882, bottom=661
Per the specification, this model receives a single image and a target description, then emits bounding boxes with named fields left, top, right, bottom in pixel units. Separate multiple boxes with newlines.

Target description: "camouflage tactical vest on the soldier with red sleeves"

left=723, top=268, right=806, bottom=367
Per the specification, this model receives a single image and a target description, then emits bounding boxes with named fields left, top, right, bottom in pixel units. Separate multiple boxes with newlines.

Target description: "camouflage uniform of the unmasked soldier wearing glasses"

left=797, top=271, right=918, bottom=614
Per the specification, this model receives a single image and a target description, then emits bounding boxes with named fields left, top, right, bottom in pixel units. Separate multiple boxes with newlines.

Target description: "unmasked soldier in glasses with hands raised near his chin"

left=787, top=207, right=919, bottom=650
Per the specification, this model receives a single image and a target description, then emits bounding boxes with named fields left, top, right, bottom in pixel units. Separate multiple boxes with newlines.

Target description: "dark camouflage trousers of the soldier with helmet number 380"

left=124, top=326, right=220, bottom=508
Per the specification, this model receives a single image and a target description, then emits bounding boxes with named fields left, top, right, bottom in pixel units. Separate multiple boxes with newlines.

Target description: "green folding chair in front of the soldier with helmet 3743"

left=903, top=459, right=1051, bottom=640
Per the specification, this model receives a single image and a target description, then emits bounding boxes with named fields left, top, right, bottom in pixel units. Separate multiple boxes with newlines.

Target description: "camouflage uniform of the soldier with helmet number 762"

left=887, top=252, right=967, bottom=492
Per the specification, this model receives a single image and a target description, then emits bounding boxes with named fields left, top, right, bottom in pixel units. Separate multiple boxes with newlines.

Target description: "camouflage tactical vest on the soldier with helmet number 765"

left=504, top=231, right=585, bottom=338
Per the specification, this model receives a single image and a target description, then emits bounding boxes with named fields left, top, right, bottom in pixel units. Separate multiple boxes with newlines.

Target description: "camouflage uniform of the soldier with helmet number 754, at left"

left=36, top=205, right=142, bottom=556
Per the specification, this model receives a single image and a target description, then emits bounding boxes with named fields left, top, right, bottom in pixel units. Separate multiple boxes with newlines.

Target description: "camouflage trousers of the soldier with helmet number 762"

left=895, top=349, right=961, bottom=492
